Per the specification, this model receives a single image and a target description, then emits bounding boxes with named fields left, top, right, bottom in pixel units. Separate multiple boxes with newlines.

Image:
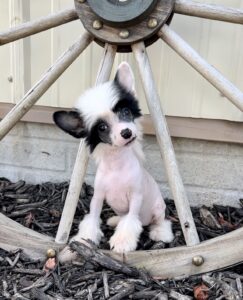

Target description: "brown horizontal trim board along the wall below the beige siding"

left=0, top=103, right=243, bottom=144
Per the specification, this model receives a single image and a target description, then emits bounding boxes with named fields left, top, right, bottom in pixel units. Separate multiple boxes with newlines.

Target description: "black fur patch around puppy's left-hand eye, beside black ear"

left=85, top=119, right=112, bottom=153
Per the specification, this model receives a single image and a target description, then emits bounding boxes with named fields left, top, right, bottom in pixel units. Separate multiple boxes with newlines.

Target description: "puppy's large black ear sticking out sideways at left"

left=53, top=110, right=86, bottom=138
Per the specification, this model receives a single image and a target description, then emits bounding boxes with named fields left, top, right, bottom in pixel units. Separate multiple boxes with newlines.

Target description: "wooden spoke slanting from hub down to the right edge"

left=159, top=25, right=243, bottom=111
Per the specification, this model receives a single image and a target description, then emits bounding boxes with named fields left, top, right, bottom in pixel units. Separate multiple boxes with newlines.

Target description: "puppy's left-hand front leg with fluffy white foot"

left=59, top=189, right=104, bottom=263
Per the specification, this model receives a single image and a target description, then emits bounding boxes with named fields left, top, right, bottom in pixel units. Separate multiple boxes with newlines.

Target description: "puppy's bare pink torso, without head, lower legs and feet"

left=95, top=146, right=165, bottom=226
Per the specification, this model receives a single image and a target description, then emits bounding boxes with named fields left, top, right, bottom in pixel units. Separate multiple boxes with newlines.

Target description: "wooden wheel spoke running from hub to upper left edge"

left=0, top=8, right=78, bottom=45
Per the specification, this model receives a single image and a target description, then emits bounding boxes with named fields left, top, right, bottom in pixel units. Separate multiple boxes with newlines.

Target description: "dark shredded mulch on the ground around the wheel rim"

left=0, top=178, right=243, bottom=300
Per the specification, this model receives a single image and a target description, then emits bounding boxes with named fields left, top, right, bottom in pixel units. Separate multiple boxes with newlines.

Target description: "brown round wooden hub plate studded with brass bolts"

left=75, top=0, right=174, bottom=52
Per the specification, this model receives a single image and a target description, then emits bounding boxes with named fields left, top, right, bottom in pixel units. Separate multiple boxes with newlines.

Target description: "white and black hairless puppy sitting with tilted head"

left=53, top=62, right=173, bottom=261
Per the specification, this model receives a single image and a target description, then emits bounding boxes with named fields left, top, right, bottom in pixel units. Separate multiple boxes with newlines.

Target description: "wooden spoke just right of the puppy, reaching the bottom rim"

left=132, top=42, right=199, bottom=246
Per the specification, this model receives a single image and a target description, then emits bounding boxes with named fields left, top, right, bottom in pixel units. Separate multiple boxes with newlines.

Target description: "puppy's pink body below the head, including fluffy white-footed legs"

left=61, top=137, right=173, bottom=261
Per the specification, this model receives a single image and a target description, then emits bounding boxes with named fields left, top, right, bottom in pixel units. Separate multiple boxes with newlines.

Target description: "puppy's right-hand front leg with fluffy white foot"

left=110, top=194, right=142, bottom=253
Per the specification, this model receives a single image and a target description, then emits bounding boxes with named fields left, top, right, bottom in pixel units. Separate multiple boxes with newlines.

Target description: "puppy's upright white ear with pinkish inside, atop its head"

left=115, top=61, right=135, bottom=94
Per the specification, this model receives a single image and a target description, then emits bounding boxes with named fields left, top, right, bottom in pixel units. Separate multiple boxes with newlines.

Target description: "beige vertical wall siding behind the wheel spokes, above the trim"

left=0, top=0, right=243, bottom=121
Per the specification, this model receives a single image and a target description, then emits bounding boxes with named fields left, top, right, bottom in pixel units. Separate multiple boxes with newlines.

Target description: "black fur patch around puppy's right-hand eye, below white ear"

left=112, top=78, right=142, bottom=122
